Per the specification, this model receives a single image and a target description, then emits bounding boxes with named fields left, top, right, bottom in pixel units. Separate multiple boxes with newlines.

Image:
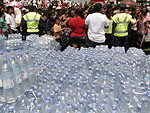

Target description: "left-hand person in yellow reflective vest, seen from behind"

left=21, top=5, right=43, bottom=40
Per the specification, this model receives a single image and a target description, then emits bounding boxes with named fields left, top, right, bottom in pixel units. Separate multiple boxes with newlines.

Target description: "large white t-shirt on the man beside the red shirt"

left=85, top=13, right=109, bottom=43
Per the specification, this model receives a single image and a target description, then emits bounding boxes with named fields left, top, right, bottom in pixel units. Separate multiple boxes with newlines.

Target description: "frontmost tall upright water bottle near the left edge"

left=2, top=59, right=17, bottom=103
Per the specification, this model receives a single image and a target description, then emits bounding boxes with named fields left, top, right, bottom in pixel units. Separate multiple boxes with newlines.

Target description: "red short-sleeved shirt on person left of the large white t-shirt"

left=69, top=17, right=86, bottom=37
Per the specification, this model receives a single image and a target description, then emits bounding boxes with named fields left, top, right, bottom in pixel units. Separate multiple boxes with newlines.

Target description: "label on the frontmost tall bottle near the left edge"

left=3, top=77, right=15, bottom=89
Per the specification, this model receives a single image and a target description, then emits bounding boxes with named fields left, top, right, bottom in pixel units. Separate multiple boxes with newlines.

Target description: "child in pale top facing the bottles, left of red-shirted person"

left=54, top=17, right=65, bottom=40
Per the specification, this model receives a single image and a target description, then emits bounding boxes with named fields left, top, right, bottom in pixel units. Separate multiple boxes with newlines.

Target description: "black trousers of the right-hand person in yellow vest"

left=112, top=36, right=129, bottom=52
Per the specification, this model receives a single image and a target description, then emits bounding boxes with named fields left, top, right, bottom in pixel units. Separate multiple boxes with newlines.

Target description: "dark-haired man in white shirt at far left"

left=5, top=6, right=18, bottom=34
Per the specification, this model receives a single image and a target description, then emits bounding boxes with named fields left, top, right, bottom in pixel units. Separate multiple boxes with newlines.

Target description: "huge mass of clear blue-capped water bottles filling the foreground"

left=0, top=46, right=150, bottom=113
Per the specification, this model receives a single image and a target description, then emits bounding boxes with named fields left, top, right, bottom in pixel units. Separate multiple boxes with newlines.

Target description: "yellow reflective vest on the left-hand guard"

left=23, top=12, right=41, bottom=33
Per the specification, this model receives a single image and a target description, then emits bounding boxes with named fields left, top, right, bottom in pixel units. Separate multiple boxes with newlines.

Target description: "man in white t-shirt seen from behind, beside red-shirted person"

left=85, top=3, right=109, bottom=47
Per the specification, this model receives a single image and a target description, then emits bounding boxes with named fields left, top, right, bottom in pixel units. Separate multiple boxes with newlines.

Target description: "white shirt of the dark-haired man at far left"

left=5, top=14, right=16, bottom=31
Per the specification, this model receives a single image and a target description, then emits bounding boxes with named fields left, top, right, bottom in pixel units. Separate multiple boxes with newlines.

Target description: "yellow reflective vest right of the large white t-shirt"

left=112, top=13, right=132, bottom=37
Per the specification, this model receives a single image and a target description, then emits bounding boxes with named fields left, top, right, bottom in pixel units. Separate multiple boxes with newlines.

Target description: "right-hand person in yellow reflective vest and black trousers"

left=112, top=5, right=132, bottom=52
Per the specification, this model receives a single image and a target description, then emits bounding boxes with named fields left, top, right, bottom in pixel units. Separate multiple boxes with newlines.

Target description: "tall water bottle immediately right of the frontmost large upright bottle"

left=10, top=56, right=24, bottom=96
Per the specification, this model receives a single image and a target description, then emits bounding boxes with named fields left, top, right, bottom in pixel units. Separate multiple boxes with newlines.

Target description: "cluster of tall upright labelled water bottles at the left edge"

left=0, top=50, right=36, bottom=103
